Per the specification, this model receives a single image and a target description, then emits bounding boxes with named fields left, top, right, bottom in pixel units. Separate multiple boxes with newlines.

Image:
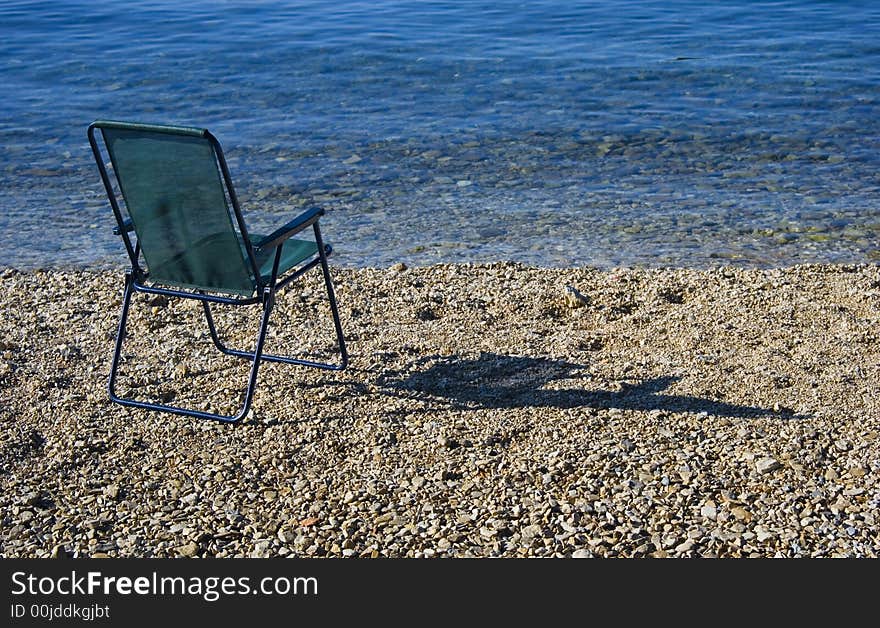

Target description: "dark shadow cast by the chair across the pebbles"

left=379, top=353, right=803, bottom=419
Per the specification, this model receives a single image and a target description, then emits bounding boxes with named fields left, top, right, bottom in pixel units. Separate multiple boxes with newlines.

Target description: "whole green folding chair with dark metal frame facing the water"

left=88, top=120, right=348, bottom=423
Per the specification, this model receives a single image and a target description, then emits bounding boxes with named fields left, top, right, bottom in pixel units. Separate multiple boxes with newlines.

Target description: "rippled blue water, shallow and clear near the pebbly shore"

left=0, top=0, right=880, bottom=268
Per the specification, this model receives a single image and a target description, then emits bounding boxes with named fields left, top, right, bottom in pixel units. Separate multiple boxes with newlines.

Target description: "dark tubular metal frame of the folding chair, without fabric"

left=88, top=120, right=348, bottom=423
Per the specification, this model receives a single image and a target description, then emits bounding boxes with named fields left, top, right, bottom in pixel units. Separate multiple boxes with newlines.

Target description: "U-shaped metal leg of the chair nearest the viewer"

left=107, top=272, right=275, bottom=423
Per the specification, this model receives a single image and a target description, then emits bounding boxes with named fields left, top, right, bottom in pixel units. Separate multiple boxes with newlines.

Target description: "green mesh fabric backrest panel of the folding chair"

left=101, top=127, right=257, bottom=295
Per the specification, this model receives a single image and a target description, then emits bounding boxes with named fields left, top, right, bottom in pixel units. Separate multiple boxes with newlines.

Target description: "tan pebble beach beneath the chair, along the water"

left=0, top=263, right=880, bottom=558
